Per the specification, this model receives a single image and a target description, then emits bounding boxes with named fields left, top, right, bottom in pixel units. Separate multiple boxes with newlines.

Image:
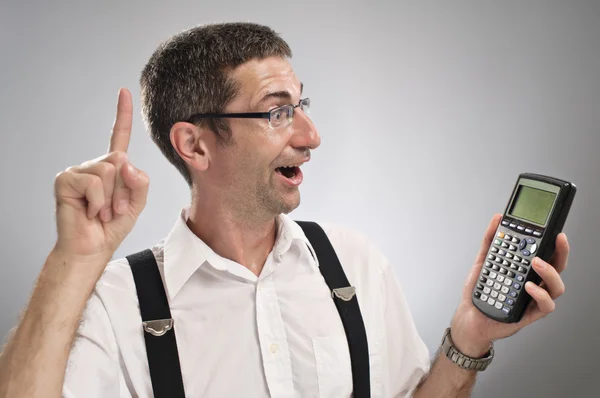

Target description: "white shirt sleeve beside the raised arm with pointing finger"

left=62, top=292, right=120, bottom=398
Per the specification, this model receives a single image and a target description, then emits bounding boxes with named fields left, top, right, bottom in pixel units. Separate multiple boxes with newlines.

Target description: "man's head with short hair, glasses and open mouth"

left=140, top=23, right=320, bottom=221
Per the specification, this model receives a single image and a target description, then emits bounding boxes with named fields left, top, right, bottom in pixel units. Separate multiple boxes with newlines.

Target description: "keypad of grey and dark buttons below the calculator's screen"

left=474, top=220, right=542, bottom=315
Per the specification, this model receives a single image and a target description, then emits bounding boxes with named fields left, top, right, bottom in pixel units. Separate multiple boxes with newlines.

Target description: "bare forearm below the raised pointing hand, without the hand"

left=0, top=251, right=108, bottom=397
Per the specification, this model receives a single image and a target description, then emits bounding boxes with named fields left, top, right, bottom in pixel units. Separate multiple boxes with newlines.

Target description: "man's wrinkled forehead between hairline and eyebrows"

left=230, top=57, right=300, bottom=101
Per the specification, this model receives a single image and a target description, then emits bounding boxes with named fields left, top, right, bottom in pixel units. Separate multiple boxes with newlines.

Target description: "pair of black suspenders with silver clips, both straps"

left=127, top=221, right=371, bottom=398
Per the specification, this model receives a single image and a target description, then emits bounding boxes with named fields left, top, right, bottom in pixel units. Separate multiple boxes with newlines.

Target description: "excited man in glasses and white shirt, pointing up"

left=0, top=23, right=569, bottom=398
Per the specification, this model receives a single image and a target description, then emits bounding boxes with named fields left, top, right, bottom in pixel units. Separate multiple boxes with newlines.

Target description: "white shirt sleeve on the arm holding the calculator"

left=383, top=264, right=431, bottom=398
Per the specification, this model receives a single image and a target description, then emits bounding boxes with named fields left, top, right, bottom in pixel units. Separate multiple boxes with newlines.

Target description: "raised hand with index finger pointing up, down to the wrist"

left=54, top=89, right=149, bottom=270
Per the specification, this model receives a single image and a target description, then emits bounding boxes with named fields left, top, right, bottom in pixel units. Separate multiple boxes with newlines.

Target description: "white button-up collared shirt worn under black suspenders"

left=63, top=208, right=430, bottom=398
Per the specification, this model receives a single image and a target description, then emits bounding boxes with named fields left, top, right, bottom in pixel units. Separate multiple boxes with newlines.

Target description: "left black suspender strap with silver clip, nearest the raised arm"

left=127, top=249, right=185, bottom=398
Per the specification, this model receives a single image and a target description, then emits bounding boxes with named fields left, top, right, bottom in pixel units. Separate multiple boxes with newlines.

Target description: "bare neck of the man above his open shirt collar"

left=187, top=191, right=277, bottom=276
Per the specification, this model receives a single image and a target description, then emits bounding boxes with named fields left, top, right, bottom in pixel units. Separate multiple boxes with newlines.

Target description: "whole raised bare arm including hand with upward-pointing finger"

left=0, top=90, right=149, bottom=398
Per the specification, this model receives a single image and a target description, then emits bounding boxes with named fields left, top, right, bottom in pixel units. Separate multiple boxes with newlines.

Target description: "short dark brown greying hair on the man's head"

left=140, top=22, right=292, bottom=186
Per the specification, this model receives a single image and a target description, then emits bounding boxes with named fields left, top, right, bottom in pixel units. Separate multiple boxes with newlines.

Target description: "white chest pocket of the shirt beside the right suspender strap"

left=312, top=334, right=352, bottom=398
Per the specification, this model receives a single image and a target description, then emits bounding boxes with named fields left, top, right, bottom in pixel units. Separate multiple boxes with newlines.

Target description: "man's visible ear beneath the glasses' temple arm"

left=171, top=122, right=215, bottom=171
